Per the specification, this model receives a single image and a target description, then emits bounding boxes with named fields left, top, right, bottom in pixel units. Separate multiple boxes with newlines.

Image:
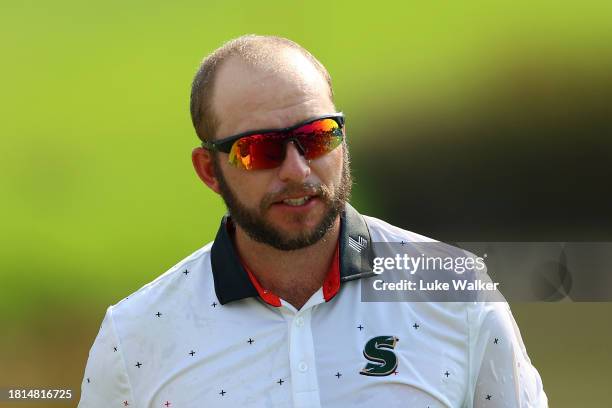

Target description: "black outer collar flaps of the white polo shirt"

left=211, top=203, right=374, bottom=305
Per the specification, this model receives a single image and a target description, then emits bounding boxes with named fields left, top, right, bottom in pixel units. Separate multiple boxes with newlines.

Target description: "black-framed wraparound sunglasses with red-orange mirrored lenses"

left=202, top=113, right=344, bottom=170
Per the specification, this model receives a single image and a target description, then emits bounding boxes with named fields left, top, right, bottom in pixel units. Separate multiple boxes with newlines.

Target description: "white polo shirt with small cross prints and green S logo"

left=79, top=204, right=548, bottom=408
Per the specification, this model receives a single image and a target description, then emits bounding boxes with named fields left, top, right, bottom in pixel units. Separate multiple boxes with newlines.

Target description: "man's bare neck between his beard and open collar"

left=235, top=217, right=340, bottom=309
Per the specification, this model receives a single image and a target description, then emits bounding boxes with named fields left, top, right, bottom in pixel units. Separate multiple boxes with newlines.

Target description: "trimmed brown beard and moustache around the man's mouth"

left=213, top=143, right=353, bottom=251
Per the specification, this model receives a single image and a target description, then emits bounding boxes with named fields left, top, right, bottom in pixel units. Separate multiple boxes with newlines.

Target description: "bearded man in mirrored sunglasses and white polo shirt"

left=79, top=36, right=547, bottom=408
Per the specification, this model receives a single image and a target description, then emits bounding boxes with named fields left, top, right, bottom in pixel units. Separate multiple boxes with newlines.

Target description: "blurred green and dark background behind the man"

left=0, top=0, right=612, bottom=407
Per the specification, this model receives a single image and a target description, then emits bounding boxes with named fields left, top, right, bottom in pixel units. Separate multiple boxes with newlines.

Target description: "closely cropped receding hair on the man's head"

left=190, top=34, right=333, bottom=141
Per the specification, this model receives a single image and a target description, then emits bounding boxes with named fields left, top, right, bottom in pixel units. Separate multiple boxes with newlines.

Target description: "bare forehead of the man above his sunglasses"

left=212, top=50, right=335, bottom=138
